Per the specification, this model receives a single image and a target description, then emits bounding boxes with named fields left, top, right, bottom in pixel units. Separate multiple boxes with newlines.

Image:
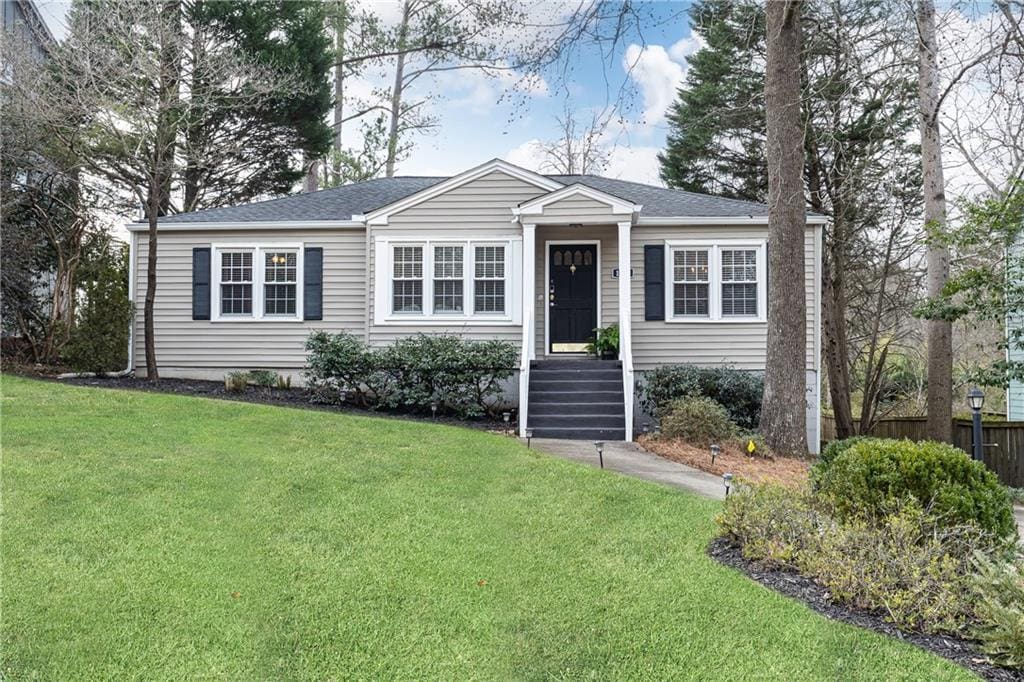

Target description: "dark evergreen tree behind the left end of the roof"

left=180, top=0, right=334, bottom=211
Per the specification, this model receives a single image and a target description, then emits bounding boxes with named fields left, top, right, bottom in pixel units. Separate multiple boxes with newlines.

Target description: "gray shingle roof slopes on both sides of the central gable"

left=151, top=175, right=768, bottom=224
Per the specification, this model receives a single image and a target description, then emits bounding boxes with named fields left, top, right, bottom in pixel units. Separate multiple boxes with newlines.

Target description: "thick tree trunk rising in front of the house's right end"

left=761, top=0, right=807, bottom=455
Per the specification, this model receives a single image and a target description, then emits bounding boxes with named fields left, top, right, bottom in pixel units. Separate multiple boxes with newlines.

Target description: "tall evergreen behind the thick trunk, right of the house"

left=659, top=0, right=922, bottom=436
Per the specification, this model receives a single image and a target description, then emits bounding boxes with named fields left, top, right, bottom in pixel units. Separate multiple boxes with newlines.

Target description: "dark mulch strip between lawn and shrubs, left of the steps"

left=33, top=375, right=515, bottom=433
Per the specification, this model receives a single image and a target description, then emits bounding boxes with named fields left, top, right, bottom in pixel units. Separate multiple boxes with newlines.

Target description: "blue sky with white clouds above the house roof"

left=37, top=0, right=699, bottom=184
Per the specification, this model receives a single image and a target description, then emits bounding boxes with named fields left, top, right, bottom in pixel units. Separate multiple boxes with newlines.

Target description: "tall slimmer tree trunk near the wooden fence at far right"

left=916, top=0, right=953, bottom=442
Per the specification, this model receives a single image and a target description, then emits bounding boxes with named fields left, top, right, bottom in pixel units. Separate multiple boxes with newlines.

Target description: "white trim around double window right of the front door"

left=665, top=239, right=768, bottom=324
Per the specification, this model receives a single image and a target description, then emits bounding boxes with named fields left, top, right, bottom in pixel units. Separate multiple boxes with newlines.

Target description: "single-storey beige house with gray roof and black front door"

left=128, top=160, right=824, bottom=450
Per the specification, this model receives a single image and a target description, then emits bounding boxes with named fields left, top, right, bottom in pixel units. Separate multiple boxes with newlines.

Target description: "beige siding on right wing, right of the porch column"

left=631, top=226, right=818, bottom=371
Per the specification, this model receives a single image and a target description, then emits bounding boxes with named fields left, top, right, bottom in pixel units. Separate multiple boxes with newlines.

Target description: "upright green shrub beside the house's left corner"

left=65, top=249, right=135, bottom=374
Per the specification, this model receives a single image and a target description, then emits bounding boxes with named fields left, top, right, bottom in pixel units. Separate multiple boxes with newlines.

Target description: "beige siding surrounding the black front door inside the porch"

left=536, top=225, right=618, bottom=357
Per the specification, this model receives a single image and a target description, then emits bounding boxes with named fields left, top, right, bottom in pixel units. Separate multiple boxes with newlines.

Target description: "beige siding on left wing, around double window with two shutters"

left=133, top=228, right=367, bottom=377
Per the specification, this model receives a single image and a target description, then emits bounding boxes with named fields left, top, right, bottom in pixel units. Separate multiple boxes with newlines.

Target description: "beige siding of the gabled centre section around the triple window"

left=367, top=171, right=546, bottom=345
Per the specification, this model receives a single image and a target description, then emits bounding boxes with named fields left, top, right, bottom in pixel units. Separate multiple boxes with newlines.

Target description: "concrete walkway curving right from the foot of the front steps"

left=532, top=438, right=1024, bottom=540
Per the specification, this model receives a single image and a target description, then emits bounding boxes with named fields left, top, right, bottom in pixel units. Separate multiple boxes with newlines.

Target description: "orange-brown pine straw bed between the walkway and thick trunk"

left=637, top=435, right=810, bottom=486
